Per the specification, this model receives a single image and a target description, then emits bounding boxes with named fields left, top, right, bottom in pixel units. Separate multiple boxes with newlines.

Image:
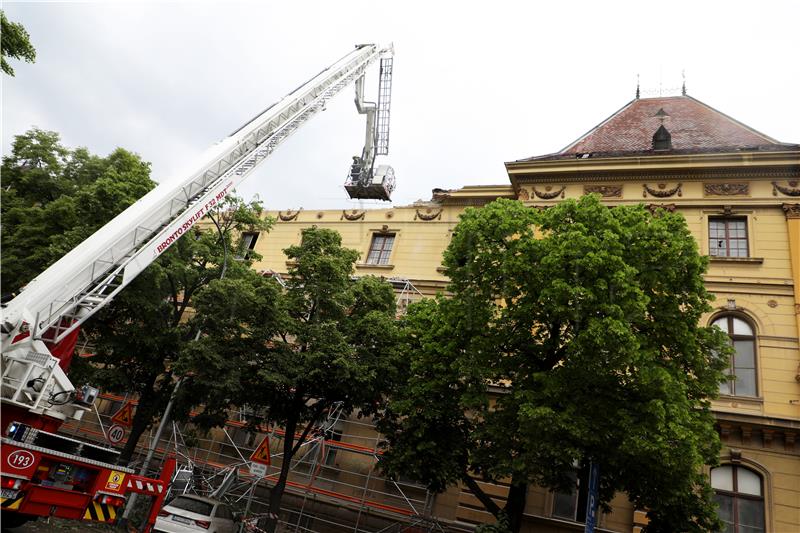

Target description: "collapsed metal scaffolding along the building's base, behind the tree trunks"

left=64, top=278, right=443, bottom=533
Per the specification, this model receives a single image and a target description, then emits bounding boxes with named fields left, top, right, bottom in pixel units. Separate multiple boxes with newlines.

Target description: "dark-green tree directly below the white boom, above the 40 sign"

left=73, top=197, right=271, bottom=463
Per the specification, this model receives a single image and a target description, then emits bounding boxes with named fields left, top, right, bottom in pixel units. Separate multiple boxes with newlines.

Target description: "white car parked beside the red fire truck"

left=153, top=494, right=238, bottom=533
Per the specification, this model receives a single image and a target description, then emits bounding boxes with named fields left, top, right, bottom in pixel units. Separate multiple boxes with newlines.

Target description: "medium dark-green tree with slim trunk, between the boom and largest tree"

left=184, top=228, right=397, bottom=531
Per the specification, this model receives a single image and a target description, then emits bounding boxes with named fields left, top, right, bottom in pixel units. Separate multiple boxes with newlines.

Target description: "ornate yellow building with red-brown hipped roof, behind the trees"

left=239, top=96, right=800, bottom=533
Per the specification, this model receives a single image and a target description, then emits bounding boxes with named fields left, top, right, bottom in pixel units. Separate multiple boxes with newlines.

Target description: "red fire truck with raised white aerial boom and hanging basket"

left=0, top=44, right=394, bottom=530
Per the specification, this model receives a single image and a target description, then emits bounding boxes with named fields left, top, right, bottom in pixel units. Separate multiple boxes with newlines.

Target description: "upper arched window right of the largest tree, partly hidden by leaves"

left=712, top=315, right=758, bottom=396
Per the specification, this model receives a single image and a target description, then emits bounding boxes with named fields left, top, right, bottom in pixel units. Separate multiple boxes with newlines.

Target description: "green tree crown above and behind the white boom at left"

left=0, top=128, right=155, bottom=294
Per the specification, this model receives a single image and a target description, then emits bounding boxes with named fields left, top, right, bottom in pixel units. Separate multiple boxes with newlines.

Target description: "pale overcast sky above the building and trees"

left=2, top=0, right=800, bottom=209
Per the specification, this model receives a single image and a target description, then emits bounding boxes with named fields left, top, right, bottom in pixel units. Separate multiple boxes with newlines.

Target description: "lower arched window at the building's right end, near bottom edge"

left=711, top=465, right=764, bottom=533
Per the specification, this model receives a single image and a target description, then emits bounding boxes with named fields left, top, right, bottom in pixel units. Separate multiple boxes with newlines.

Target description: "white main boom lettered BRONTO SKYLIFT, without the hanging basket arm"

left=0, top=44, right=393, bottom=419
